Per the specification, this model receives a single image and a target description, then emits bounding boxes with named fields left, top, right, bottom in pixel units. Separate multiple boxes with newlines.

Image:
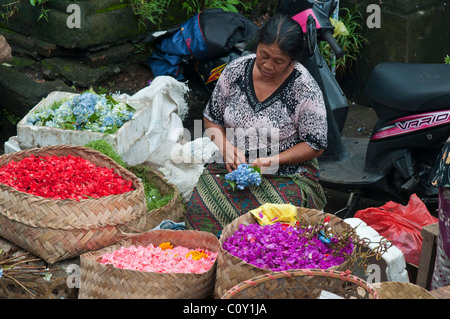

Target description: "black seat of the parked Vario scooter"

left=365, top=62, right=450, bottom=119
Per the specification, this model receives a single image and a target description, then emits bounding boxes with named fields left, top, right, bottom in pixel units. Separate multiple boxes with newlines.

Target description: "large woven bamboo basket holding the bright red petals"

left=0, top=145, right=147, bottom=264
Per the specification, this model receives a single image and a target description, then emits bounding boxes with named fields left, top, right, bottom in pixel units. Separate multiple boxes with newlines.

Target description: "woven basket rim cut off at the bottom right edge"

left=373, top=281, right=438, bottom=299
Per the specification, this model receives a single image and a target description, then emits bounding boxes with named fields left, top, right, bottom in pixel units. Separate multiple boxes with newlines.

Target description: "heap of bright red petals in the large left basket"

left=0, top=155, right=133, bottom=200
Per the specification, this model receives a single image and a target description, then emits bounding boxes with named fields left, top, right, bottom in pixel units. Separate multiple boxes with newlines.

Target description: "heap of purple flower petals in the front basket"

left=223, top=216, right=354, bottom=271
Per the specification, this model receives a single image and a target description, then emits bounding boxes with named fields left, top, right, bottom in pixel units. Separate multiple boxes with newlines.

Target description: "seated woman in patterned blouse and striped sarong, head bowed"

left=187, top=15, right=327, bottom=235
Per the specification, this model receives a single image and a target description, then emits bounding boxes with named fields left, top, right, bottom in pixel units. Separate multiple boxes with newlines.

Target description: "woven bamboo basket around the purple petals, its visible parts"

left=215, top=207, right=353, bottom=298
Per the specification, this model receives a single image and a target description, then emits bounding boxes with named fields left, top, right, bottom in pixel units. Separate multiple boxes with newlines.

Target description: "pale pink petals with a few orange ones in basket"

left=97, top=242, right=218, bottom=273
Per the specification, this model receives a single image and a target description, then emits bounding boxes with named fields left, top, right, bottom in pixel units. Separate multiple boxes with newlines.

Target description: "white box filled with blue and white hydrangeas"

left=17, top=92, right=151, bottom=156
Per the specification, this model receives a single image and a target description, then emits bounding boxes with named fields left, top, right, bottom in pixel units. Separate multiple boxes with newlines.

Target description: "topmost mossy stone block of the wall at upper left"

left=0, top=0, right=142, bottom=49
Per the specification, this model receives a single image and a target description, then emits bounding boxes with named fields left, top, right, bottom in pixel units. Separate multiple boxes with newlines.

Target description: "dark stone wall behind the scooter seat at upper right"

left=340, top=0, right=450, bottom=103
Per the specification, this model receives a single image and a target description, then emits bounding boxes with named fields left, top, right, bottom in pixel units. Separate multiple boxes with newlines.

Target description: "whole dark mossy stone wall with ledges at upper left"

left=0, top=0, right=146, bottom=117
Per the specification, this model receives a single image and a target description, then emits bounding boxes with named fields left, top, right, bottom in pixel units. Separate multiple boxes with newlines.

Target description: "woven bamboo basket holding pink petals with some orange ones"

left=78, top=230, right=219, bottom=299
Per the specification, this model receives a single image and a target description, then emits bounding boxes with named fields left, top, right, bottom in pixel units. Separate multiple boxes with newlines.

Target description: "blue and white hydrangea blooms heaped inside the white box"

left=27, top=91, right=135, bottom=134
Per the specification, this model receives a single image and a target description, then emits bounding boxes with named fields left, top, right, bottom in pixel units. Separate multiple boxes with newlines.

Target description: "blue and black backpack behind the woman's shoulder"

left=146, top=9, right=258, bottom=80
